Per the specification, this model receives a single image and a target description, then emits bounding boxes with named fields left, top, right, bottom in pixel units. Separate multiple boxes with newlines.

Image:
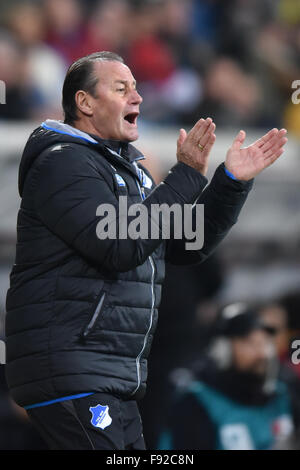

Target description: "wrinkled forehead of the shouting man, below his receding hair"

left=94, top=60, right=135, bottom=84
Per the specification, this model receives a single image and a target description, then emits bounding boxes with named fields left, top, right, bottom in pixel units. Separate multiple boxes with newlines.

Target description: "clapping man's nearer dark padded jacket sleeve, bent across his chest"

left=34, top=146, right=207, bottom=272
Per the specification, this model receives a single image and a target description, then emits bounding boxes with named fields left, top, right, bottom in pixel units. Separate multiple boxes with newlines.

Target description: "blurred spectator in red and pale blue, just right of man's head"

left=125, top=0, right=201, bottom=124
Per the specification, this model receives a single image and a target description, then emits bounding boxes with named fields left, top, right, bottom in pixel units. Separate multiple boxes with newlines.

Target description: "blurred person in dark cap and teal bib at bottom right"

left=159, top=303, right=299, bottom=450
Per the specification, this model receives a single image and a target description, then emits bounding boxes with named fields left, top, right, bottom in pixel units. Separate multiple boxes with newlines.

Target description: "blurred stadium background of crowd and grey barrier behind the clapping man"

left=0, top=0, right=300, bottom=449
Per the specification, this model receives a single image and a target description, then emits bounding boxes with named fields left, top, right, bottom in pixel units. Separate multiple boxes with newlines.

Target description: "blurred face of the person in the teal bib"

left=232, top=330, right=274, bottom=375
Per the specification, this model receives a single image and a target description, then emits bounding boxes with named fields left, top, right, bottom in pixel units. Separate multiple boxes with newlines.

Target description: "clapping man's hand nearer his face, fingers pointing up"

left=177, top=118, right=216, bottom=175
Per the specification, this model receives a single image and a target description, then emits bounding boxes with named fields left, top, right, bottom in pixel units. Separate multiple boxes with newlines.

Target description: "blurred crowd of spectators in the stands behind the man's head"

left=0, top=0, right=300, bottom=134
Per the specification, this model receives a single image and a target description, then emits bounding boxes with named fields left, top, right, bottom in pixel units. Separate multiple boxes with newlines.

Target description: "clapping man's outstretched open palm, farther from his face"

left=225, top=129, right=288, bottom=181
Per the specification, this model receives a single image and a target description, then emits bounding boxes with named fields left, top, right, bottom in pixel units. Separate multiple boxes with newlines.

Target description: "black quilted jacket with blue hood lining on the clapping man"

left=6, top=120, right=252, bottom=406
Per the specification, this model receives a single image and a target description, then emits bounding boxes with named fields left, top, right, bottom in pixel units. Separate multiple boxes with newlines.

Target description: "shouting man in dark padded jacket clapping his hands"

left=6, top=52, right=287, bottom=449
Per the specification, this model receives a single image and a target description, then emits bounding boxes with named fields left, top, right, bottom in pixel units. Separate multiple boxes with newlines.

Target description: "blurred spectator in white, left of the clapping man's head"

left=0, top=0, right=66, bottom=119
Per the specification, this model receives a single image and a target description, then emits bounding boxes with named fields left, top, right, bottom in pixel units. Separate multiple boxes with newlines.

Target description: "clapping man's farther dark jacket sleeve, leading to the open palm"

left=166, top=162, right=254, bottom=265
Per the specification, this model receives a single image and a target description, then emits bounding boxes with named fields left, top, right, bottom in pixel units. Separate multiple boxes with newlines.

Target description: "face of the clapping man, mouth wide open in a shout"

left=90, top=60, right=142, bottom=142
